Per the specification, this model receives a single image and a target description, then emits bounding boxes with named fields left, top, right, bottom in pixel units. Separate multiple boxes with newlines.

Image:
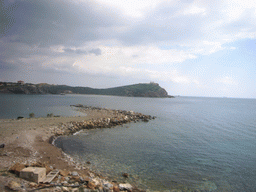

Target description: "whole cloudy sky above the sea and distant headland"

left=0, top=0, right=256, bottom=98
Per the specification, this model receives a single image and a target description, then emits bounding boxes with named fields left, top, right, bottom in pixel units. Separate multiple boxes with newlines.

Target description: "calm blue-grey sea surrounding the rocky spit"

left=0, top=94, right=256, bottom=192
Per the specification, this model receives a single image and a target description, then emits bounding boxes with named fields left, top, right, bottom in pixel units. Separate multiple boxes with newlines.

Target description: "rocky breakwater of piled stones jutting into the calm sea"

left=51, top=104, right=156, bottom=138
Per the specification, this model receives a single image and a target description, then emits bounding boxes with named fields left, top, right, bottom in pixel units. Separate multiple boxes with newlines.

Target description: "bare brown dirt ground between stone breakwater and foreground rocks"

left=0, top=110, right=114, bottom=191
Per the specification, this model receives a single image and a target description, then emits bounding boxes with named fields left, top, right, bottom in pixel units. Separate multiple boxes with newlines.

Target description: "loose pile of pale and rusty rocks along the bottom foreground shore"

left=7, top=163, right=137, bottom=192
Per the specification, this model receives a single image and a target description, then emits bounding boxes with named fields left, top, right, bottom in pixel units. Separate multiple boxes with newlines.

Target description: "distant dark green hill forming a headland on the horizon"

left=0, top=82, right=172, bottom=97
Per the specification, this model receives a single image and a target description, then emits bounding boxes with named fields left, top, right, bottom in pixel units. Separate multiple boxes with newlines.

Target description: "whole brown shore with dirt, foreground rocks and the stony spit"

left=0, top=105, right=155, bottom=192
